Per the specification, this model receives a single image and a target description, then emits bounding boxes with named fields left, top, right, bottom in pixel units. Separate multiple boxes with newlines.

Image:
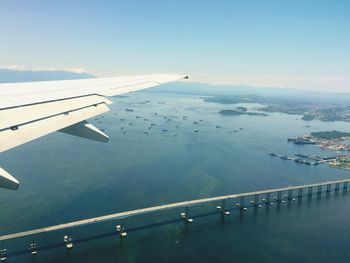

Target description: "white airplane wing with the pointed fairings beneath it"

left=0, top=74, right=187, bottom=189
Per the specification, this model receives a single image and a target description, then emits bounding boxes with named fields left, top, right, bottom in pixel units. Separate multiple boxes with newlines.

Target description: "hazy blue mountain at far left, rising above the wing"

left=0, top=68, right=95, bottom=83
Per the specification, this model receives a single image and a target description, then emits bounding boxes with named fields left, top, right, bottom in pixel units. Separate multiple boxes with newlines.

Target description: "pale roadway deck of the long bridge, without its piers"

left=0, top=179, right=350, bottom=241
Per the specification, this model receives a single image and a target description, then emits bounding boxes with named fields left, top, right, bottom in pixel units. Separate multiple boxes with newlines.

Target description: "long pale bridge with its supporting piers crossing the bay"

left=0, top=179, right=350, bottom=244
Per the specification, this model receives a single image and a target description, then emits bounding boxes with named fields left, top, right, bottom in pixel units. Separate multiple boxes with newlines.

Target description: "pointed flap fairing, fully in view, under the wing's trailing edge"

left=59, top=121, right=109, bottom=142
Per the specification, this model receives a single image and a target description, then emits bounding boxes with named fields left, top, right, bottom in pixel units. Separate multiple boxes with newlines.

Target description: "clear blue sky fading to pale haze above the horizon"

left=0, top=0, right=350, bottom=92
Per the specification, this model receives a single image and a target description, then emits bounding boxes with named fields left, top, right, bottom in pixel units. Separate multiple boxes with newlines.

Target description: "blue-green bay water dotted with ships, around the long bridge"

left=0, top=89, right=350, bottom=262
